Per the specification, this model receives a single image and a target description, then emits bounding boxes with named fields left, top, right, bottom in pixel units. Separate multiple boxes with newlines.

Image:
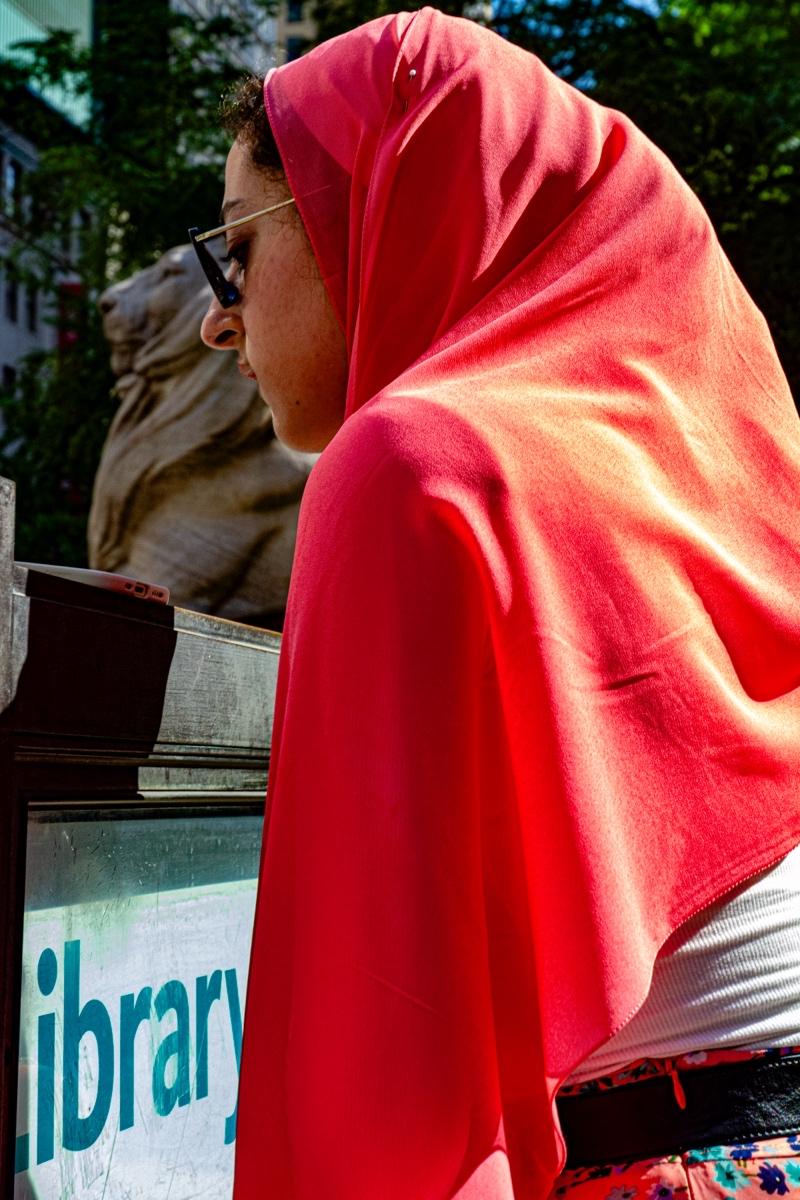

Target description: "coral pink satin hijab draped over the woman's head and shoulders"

left=235, top=10, right=800, bottom=1200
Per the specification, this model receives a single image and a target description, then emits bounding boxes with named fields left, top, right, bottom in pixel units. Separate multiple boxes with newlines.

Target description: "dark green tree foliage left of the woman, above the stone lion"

left=0, top=0, right=272, bottom=564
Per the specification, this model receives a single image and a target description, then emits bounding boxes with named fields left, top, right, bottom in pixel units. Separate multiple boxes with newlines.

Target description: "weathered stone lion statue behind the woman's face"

left=89, top=246, right=314, bottom=629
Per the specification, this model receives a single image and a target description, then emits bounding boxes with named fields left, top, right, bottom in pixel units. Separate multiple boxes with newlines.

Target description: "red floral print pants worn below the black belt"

left=549, top=1046, right=800, bottom=1200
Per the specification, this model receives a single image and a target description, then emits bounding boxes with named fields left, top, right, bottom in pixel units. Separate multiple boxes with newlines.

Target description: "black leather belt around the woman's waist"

left=558, top=1055, right=800, bottom=1168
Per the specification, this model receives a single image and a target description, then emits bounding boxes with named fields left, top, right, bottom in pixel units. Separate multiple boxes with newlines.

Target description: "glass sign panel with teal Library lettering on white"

left=14, top=809, right=261, bottom=1200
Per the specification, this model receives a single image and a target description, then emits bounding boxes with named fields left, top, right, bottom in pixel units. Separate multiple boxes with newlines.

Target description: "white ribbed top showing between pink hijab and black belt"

left=570, top=829, right=800, bottom=1082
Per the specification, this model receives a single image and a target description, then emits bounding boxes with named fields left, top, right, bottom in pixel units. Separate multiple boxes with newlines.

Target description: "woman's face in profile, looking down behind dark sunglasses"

left=200, top=142, right=348, bottom=451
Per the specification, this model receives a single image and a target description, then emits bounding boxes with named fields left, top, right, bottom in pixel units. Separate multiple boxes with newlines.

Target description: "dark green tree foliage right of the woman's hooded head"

left=671, top=0, right=800, bottom=403
